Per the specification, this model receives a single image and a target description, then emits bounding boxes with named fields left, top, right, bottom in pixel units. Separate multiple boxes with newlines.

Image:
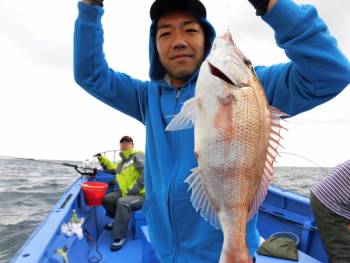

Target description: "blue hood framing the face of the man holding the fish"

left=149, top=17, right=216, bottom=84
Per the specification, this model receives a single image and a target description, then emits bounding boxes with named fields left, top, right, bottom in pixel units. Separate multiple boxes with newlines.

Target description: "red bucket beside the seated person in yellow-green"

left=81, top=182, right=108, bottom=206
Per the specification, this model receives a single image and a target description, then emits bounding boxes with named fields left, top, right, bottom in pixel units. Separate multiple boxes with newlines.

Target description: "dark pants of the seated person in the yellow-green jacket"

left=102, top=192, right=145, bottom=239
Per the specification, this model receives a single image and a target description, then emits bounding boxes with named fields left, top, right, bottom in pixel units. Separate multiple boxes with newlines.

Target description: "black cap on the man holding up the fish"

left=150, top=0, right=207, bottom=21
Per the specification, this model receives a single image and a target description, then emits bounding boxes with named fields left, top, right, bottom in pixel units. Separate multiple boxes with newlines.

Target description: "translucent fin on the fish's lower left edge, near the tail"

left=185, top=167, right=221, bottom=229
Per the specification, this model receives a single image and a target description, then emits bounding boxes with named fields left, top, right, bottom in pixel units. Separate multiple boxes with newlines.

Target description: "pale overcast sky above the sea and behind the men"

left=0, top=0, right=350, bottom=166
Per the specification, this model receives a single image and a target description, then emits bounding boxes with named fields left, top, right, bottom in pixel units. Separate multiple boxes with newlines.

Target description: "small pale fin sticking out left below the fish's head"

left=165, top=97, right=199, bottom=131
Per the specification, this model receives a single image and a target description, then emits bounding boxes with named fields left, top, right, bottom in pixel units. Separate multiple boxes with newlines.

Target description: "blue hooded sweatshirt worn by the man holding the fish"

left=74, top=0, right=350, bottom=263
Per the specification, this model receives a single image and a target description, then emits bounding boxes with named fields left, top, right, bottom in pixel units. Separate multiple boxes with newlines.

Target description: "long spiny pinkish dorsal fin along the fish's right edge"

left=248, top=106, right=289, bottom=219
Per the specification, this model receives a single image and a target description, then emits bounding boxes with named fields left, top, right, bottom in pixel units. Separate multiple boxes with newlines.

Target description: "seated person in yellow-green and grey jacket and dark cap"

left=96, top=136, right=145, bottom=251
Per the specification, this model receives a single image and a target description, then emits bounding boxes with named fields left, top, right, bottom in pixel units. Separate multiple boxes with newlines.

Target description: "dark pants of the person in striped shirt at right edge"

left=310, top=193, right=350, bottom=263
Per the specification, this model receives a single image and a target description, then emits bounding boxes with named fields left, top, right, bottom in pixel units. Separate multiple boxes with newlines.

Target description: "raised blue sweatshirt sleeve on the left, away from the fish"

left=74, top=2, right=147, bottom=122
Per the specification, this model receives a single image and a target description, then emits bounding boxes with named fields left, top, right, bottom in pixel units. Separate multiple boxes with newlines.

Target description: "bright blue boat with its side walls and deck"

left=11, top=172, right=328, bottom=263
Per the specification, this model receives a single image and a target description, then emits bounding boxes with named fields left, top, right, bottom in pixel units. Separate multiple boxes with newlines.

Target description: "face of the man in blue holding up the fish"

left=156, top=11, right=205, bottom=86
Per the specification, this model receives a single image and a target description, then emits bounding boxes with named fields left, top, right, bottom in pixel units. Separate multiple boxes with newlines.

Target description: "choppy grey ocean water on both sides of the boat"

left=0, top=158, right=330, bottom=263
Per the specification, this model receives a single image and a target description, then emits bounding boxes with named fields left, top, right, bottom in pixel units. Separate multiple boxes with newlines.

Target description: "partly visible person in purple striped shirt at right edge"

left=310, top=160, right=350, bottom=263
